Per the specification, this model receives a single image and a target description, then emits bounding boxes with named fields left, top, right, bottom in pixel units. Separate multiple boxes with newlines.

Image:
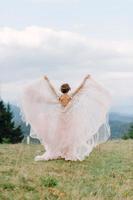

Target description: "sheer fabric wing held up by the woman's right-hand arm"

left=62, top=77, right=111, bottom=159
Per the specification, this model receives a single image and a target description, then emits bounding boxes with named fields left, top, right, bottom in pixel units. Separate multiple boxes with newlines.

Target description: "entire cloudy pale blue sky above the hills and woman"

left=0, top=0, right=133, bottom=114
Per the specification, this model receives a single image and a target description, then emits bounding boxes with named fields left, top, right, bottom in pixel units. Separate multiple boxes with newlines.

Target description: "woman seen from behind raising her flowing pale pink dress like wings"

left=21, top=75, right=111, bottom=161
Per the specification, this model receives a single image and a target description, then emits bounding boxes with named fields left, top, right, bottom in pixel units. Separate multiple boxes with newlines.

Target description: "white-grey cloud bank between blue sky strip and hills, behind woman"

left=0, top=26, right=133, bottom=111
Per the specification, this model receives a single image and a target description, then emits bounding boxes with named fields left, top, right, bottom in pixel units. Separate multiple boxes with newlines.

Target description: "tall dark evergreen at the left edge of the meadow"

left=0, top=100, right=23, bottom=144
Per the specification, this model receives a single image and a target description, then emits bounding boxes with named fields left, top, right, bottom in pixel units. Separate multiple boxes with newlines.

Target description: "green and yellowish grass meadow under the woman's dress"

left=0, top=140, right=133, bottom=200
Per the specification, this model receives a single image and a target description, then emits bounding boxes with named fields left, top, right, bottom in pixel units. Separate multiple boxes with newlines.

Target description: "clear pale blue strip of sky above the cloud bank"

left=0, top=0, right=133, bottom=39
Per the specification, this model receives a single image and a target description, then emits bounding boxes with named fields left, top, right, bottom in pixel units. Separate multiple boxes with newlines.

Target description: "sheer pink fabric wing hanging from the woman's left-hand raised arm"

left=20, top=78, right=59, bottom=140
